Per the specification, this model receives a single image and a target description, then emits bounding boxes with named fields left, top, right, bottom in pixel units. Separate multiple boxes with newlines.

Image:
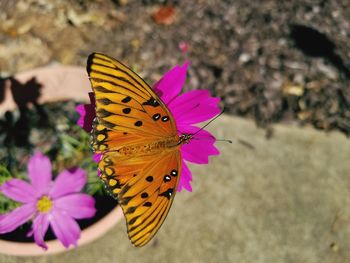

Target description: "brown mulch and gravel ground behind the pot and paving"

left=0, top=0, right=350, bottom=135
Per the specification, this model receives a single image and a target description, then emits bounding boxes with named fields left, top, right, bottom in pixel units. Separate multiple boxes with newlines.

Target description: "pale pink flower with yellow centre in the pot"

left=0, top=153, right=96, bottom=250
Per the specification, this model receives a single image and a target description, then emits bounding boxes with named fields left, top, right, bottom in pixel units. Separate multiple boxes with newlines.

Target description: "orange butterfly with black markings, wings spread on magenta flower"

left=87, top=53, right=193, bottom=247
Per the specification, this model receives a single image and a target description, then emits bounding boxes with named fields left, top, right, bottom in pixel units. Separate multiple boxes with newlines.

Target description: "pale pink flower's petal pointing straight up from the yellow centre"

left=28, top=152, right=52, bottom=194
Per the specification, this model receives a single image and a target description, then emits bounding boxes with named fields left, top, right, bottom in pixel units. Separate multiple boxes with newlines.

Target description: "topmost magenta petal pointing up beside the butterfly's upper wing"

left=153, top=61, right=189, bottom=104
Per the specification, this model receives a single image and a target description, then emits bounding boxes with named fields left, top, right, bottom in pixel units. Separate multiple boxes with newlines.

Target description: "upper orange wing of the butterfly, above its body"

left=87, top=53, right=177, bottom=152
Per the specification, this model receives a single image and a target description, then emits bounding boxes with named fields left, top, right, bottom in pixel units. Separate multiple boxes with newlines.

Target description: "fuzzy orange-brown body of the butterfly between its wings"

left=117, top=136, right=179, bottom=156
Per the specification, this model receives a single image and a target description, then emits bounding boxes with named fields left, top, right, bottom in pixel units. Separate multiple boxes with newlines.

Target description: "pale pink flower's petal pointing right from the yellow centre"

left=54, top=194, right=96, bottom=219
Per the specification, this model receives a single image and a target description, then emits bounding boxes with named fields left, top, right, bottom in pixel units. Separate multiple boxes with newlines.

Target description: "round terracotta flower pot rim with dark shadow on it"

left=0, top=66, right=123, bottom=256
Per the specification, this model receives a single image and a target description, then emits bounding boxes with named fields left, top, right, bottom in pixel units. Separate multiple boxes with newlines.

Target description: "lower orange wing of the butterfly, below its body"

left=99, top=150, right=181, bottom=246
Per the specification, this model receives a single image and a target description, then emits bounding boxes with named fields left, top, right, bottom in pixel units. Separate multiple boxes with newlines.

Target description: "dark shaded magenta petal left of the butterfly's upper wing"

left=75, top=92, right=96, bottom=132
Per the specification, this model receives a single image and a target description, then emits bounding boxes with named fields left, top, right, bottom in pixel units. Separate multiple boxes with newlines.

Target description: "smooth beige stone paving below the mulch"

left=0, top=116, right=350, bottom=263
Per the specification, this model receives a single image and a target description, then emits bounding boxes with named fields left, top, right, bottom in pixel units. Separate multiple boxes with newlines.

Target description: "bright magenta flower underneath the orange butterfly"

left=77, top=62, right=221, bottom=192
